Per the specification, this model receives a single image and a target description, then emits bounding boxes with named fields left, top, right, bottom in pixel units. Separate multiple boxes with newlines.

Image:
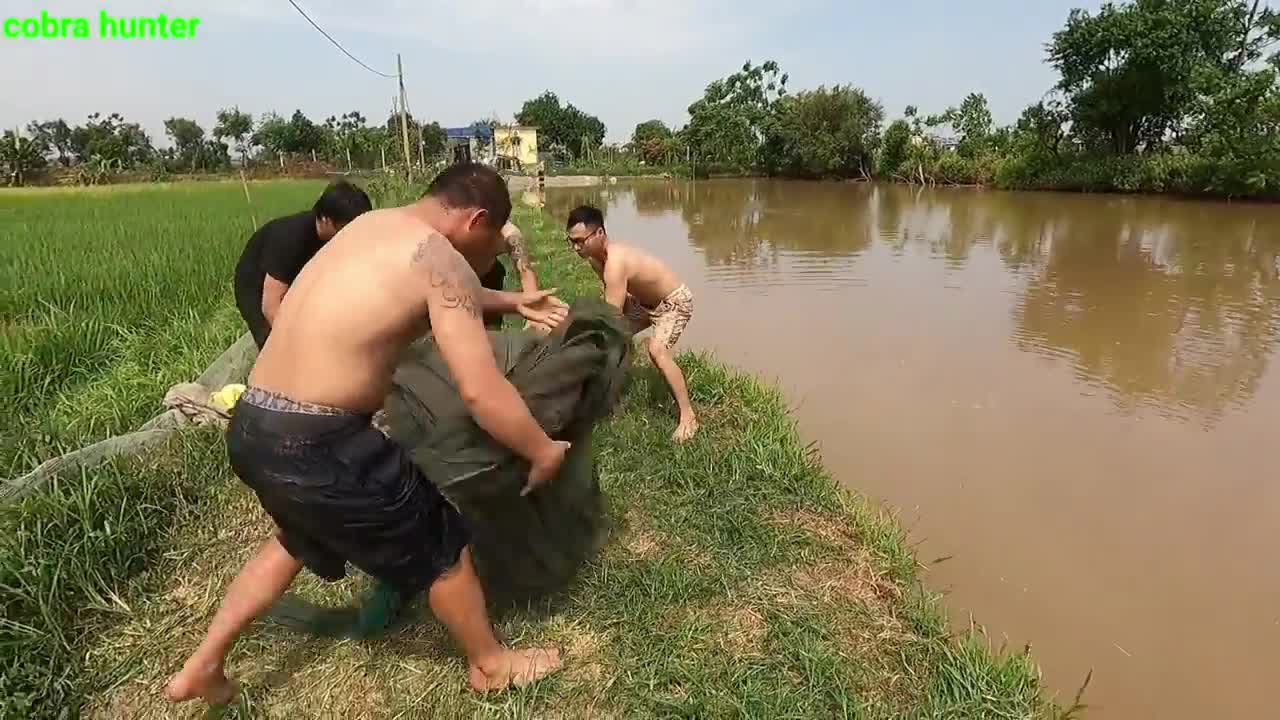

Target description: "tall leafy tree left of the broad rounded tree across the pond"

left=682, top=60, right=787, bottom=169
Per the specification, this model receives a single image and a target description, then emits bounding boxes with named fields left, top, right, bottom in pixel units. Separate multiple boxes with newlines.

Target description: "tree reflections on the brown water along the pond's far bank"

left=547, top=179, right=1280, bottom=424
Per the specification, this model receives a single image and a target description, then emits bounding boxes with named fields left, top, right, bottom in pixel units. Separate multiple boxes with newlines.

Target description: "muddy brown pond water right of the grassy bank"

left=547, top=181, right=1280, bottom=719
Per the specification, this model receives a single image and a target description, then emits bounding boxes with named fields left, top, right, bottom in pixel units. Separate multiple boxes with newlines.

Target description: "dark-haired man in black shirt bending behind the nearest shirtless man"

left=236, top=181, right=372, bottom=350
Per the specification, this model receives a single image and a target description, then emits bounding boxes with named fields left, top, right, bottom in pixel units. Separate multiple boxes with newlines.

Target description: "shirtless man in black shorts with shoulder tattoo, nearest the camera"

left=166, top=164, right=568, bottom=703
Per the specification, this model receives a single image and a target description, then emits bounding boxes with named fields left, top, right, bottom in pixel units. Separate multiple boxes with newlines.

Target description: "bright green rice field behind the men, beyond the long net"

left=0, top=181, right=324, bottom=478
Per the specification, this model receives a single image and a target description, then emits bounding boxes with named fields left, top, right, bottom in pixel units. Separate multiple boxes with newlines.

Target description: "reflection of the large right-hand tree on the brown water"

left=1014, top=193, right=1277, bottom=424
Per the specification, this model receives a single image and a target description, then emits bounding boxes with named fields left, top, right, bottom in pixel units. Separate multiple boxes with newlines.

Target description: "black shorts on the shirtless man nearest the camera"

left=227, top=388, right=468, bottom=596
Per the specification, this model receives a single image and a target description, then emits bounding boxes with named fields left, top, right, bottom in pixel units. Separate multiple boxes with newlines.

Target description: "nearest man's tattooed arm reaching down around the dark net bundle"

left=412, top=233, right=564, bottom=486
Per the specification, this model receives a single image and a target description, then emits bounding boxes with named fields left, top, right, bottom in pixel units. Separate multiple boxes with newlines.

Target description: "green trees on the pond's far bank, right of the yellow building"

left=665, top=0, right=1280, bottom=197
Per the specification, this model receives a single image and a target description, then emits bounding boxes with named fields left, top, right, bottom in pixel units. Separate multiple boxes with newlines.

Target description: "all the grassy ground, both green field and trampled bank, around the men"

left=0, top=183, right=1064, bottom=719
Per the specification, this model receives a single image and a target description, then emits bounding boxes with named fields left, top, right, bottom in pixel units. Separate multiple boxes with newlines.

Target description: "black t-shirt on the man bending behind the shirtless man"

left=236, top=210, right=324, bottom=328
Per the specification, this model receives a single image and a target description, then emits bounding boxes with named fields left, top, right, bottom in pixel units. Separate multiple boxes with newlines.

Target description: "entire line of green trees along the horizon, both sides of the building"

left=0, top=0, right=1280, bottom=197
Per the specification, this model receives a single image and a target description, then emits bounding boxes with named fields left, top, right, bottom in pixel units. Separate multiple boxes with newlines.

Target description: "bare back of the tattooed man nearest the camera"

left=250, top=208, right=479, bottom=413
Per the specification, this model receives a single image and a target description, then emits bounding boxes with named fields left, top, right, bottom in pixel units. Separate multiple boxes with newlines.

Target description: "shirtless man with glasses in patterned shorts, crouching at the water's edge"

left=566, top=205, right=698, bottom=442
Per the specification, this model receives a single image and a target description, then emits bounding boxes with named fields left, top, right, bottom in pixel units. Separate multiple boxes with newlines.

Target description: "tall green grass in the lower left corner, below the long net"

left=0, top=433, right=225, bottom=719
